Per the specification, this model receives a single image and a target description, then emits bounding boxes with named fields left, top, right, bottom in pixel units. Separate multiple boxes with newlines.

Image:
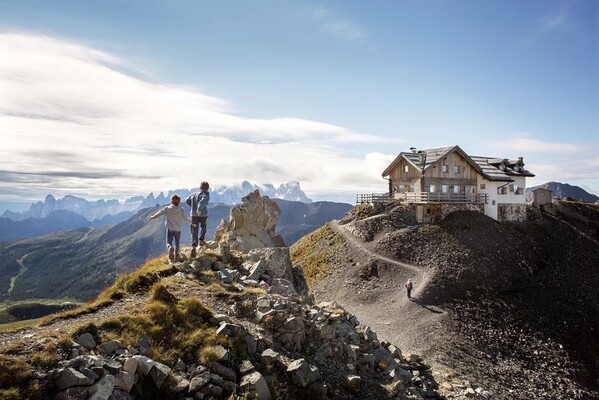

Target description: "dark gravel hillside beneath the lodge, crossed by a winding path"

left=294, top=202, right=599, bottom=399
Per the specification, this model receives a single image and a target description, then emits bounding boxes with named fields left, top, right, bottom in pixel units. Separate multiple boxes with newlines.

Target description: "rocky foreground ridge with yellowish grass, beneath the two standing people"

left=0, top=191, right=450, bottom=400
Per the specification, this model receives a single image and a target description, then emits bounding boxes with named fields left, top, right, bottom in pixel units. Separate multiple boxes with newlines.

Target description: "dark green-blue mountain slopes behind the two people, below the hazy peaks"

left=0, top=199, right=352, bottom=301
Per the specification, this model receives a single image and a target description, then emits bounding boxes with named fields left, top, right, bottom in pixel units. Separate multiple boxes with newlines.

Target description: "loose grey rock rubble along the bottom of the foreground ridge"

left=45, top=294, right=438, bottom=400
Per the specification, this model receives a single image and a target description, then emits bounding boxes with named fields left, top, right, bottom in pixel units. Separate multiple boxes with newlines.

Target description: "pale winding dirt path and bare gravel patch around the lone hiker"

left=324, top=221, right=448, bottom=357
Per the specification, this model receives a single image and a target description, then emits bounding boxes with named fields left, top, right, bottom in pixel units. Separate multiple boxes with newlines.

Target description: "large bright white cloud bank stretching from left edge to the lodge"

left=0, top=34, right=385, bottom=203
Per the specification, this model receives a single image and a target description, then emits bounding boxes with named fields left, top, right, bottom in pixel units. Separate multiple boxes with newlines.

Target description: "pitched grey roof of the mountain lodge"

left=383, top=146, right=534, bottom=182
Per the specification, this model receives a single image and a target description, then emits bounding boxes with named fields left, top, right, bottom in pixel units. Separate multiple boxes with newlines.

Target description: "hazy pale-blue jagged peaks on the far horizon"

left=2, top=181, right=312, bottom=225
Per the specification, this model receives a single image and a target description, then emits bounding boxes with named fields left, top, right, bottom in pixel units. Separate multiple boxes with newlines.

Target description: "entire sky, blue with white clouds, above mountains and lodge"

left=0, top=0, right=599, bottom=206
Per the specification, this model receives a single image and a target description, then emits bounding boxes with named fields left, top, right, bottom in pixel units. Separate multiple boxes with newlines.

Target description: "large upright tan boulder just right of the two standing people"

left=214, top=190, right=285, bottom=253
